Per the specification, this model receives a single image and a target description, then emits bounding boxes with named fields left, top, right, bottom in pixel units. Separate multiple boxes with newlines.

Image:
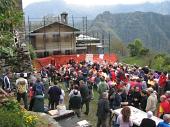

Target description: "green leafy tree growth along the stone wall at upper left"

left=0, top=0, right=23, bottom=70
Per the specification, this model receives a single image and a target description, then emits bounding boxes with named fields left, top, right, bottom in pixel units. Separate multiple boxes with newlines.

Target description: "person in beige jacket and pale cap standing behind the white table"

left=146, top=87, right=158, bottom=113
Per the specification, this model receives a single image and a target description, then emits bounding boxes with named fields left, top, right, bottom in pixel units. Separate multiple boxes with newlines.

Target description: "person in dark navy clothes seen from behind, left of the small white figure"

left=48, top=85, right=62, bottom=110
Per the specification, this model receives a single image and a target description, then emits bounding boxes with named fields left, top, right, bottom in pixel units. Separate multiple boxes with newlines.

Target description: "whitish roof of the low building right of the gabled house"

left=76, top=34, right=100, bottom=41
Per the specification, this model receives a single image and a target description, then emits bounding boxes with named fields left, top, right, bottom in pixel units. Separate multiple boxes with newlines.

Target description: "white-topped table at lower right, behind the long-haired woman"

left=112, top=106, right=163, bottom=126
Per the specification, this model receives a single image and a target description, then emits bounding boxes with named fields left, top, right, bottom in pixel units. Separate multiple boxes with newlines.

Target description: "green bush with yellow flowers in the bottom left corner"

left=0, top=99, right=38, bottom=127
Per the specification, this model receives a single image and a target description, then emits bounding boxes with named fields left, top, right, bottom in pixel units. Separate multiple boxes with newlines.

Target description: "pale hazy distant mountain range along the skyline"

left=24, top=0, right=170, bottom=19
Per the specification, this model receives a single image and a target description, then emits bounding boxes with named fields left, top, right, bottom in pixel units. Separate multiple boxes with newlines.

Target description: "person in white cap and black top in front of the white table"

left=140, top=111, right=156, bottom=127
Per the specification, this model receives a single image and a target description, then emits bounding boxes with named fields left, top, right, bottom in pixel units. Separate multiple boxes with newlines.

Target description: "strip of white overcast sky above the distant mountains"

left=22, top=0, right=165, bottom=8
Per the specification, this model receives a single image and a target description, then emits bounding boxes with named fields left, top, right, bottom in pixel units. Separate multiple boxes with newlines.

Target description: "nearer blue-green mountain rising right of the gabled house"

left=88, top=11, right=170, bottom=52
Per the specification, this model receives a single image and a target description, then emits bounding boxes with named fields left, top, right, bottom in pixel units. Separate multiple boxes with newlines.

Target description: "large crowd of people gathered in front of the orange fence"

left=0, top=60, right=170, bottom=127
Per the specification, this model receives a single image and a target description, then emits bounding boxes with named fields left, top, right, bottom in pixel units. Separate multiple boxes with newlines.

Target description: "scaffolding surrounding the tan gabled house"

left=25, top=13, right=110, bottom=57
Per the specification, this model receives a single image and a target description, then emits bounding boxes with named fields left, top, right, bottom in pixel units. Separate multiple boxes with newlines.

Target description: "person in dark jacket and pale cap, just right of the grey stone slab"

left=69, top=90, right=82, bottom=117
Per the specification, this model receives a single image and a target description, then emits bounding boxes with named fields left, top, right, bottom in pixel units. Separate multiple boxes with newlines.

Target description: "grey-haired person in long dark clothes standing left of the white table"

left=96, top=92, right=110, bottom=127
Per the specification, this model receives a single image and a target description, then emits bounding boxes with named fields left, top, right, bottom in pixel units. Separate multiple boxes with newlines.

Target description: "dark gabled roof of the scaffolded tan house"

left=30, top=21, right=80, bottom=33
